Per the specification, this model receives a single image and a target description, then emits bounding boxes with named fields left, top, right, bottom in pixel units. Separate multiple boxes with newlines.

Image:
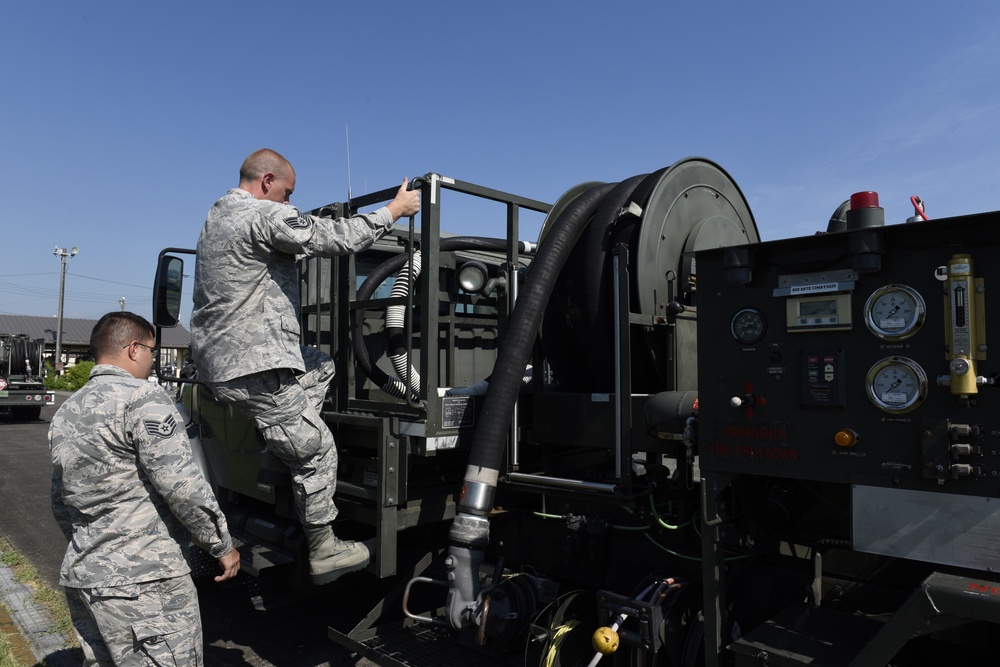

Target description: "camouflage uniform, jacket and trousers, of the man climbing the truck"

left=191, top=188, right=393, bottom=525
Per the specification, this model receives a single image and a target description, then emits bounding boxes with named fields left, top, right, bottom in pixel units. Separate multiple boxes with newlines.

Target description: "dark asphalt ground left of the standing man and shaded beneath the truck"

left=0, top=393, right=374, bottom=667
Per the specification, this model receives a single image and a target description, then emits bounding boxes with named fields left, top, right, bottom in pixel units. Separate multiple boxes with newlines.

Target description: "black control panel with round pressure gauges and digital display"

left=696, top=213, right=1000, bottom=497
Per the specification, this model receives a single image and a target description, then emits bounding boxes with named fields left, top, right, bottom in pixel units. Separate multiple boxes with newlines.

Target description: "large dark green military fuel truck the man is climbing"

left=154, top=162, right=1000, bottom=667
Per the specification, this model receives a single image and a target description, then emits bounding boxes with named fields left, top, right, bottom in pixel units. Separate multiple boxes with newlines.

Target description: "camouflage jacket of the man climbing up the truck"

left=191, top=188, right=393, bottom=382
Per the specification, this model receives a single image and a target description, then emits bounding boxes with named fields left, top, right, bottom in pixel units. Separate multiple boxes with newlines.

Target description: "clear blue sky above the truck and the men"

left=0, top=0, right=1000, bottom=326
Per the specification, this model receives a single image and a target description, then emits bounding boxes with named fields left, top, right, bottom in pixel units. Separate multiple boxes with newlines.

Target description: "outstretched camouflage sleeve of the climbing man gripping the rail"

left=259, top=202, right=394, bottom=257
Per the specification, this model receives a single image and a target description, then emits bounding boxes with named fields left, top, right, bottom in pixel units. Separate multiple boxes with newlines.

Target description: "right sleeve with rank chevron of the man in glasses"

left=125, top=383, right=233, bottom=558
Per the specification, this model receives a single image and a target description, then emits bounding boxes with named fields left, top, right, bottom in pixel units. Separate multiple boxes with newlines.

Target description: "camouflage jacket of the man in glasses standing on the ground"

left=49, top=364, right=233, bottom=588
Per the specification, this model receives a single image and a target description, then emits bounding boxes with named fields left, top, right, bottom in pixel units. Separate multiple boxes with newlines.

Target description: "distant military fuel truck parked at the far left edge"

left=0, top=333, right=55, bottom=421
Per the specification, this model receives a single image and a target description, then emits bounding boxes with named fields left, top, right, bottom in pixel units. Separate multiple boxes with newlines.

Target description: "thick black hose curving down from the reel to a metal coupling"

left=460, top=183, right=615, bottom=490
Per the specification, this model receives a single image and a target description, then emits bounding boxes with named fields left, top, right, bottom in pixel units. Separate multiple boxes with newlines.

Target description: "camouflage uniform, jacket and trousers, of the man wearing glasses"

left=49, top=364, right=233, bottom=665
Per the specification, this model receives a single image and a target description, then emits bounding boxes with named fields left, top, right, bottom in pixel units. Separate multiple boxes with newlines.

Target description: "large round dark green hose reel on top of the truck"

left=539, top=157, right=760, bottom=393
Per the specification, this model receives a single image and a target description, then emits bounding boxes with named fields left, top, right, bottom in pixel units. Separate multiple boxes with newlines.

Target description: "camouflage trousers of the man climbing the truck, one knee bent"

left=211, top=347, right=337, bottom=526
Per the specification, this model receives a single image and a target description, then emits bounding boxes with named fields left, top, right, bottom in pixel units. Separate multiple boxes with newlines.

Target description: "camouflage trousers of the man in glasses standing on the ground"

left=66, top=575, right=204, bottom=667
